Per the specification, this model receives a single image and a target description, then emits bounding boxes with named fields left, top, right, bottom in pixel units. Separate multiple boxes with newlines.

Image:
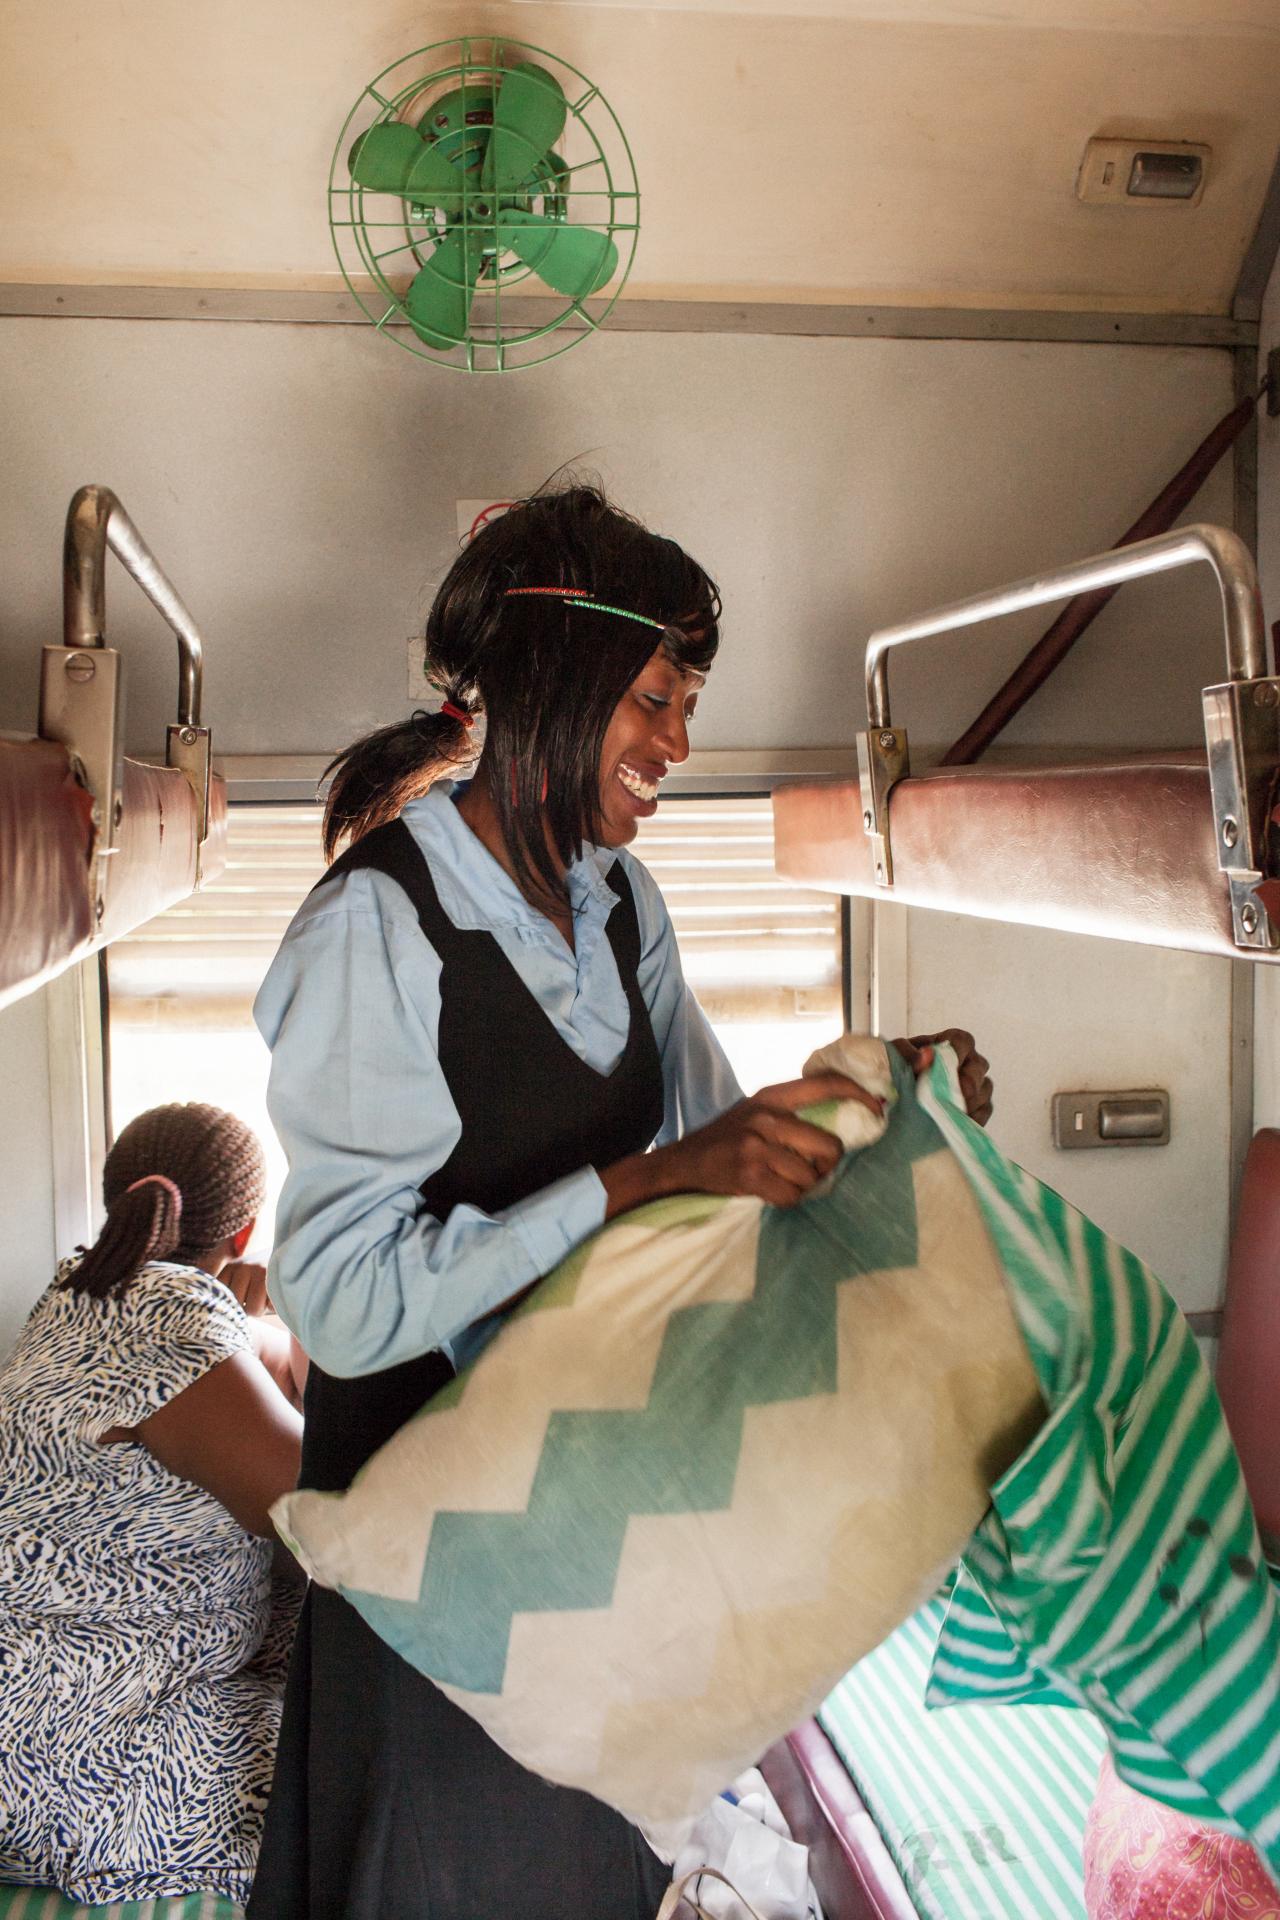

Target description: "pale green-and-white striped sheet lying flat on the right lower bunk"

left=818, top=1597, right=1105, bottom=1920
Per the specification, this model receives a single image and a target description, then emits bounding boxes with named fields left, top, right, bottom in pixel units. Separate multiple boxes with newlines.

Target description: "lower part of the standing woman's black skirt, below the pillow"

left=248, top=1588, right=670, bottom=1920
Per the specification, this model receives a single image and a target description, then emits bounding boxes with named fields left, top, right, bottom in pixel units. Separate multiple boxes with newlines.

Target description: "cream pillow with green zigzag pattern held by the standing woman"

left=276, top=1041, right=1040, bottom=1851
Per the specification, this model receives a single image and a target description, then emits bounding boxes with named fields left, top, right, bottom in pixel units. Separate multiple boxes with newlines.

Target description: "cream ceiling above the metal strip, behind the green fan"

left=0, top=0, right=1280, bottom=313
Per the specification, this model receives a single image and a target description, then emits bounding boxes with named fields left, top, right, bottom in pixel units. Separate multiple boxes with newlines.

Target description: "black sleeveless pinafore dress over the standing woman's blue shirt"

left=248, top=820, right=670, bottom=1920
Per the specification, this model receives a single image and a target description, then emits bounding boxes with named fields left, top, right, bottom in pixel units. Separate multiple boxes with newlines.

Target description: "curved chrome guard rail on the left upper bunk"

left=61, top=486, right=203, bottom=728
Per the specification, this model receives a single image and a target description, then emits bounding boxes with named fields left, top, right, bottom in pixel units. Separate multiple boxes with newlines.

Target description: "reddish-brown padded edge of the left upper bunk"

left=0, top=739, right=226, bottom=1006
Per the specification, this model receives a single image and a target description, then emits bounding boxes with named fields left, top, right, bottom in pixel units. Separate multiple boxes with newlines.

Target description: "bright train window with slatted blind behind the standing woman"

left=107, top=797, right=844, bottom=1256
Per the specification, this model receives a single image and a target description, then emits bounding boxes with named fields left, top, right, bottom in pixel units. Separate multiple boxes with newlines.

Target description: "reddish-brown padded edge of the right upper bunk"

left=773, top=749, right=1280, bottom=962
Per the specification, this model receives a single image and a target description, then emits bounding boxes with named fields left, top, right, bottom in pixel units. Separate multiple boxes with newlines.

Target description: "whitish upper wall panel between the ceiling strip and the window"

left=0, top=319, right=1230, bottom=753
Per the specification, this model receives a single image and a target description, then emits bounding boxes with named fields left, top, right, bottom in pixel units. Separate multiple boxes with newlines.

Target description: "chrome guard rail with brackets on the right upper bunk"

left=858, top=526, right=1280, bottom=952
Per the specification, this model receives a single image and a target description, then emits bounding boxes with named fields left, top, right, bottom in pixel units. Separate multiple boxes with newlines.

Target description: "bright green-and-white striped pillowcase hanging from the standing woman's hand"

left=921, top=1058, right=1280, bottom=1872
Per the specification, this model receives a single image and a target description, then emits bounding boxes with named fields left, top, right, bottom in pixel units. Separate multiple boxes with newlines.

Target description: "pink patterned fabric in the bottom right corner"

left=1084, top=1755, right=1280, bottom=1920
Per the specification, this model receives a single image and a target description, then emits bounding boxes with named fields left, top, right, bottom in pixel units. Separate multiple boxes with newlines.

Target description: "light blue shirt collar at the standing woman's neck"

left=401, top=780, right=618, bottom=931
